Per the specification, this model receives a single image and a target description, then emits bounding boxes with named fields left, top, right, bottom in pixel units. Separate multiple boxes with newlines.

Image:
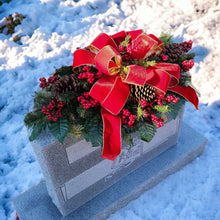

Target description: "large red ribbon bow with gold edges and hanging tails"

left=73, top=30, right=198, bottom=160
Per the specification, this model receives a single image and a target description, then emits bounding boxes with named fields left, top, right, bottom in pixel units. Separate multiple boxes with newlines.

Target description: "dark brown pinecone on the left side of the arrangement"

left=52, top=74, right=79, bottom=95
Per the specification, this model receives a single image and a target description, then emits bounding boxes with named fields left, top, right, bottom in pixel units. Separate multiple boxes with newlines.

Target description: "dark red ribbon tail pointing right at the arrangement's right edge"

left=168, top=85, right=199, bottom=110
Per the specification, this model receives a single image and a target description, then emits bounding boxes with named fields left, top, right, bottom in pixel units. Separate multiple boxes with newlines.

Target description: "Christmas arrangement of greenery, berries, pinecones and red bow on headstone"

left=24, top=30, right=198, bottom=160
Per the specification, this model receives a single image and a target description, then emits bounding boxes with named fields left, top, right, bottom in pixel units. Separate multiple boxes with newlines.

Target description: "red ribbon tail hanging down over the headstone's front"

left=102, top=108, right=121, bottom=161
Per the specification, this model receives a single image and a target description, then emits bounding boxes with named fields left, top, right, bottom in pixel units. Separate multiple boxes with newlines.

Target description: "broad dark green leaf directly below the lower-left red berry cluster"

left=48, top=117, right=70, bottom=143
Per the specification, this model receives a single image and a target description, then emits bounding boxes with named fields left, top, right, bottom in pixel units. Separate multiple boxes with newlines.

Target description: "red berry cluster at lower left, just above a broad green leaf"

left=41, top=97, right=64, bottom=121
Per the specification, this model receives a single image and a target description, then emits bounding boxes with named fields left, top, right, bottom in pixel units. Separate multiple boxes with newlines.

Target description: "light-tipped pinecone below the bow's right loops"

left=128, top=84, right=156, bottom=103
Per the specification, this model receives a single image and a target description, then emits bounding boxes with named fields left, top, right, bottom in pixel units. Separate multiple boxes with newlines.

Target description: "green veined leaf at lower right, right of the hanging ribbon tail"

left=139, top=123, right=157, bottom=142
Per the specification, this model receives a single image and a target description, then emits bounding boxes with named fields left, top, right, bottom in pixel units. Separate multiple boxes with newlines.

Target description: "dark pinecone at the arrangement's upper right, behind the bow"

left=163, top=43, right=183, bottom=63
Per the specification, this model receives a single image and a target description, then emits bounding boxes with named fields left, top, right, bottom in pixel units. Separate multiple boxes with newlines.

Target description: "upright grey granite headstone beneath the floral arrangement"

left=31, top=107, right=184, bottom=216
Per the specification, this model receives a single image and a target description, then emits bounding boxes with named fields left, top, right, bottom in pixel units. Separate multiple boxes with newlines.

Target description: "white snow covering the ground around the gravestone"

left=0, top=0, right=220, bottom=220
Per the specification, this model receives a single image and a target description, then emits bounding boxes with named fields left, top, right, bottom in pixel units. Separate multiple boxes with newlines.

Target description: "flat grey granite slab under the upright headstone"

left=13, top=123, right=207, bottom=220
